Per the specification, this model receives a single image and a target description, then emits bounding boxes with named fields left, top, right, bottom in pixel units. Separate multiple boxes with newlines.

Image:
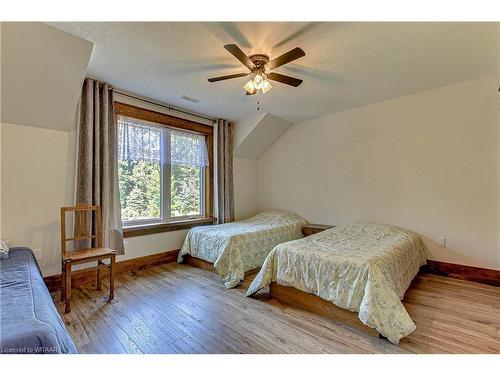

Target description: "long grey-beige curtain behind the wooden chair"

left=75, top=78, right=124, bottom=254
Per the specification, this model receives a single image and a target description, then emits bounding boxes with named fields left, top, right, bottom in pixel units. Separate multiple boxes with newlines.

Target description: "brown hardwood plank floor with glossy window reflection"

left=52, top=263, right=500, bottom=353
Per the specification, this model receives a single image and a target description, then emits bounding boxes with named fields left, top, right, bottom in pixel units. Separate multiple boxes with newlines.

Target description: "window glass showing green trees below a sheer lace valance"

left=118, top=116, right=204, bottom=222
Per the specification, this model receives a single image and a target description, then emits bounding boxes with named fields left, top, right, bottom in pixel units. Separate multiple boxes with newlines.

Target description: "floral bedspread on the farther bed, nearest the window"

left=177, top=211, right=307, bottom=288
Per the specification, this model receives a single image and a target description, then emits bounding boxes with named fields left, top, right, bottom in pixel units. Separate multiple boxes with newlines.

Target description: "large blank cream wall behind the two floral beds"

left=258, top=77, right=500, bottom=269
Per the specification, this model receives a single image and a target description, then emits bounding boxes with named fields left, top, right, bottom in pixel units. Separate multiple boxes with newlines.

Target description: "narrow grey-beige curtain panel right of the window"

left=216, top=120, right=234, bottom=224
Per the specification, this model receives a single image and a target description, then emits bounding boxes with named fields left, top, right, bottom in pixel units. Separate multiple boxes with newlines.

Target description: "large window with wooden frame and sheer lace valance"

left=115, top=103, right=213, bottom=232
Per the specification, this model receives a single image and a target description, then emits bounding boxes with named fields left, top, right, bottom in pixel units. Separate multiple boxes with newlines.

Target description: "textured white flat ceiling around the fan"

left=47, top=22, right=500, bottom=122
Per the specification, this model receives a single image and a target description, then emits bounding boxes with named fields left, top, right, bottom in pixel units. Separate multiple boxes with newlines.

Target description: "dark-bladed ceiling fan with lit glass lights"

left=208, top=44, right=306, bottom=95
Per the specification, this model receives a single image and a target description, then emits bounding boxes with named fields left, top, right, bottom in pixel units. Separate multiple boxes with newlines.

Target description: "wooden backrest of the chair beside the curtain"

left=61, top=205, right=102, bottom=254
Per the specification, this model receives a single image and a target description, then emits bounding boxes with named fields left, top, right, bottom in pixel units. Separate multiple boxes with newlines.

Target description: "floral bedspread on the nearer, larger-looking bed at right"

left=247, top=223, right=426, bottom=344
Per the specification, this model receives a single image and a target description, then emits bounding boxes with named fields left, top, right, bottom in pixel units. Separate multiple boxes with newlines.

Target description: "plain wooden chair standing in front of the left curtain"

left=61, top=205, right=116, bottom=314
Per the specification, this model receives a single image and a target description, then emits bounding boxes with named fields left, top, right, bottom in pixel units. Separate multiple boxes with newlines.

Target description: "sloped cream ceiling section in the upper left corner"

left=0, top=22, right=93, bottom=130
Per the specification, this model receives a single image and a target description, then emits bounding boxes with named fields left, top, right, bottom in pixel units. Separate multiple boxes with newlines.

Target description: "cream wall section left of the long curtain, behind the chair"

left=0, top=123, right=74, bottom=274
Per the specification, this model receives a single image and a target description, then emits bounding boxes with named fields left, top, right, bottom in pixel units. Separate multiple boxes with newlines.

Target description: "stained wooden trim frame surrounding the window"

left=114, top=101, right=215, bottom=237
